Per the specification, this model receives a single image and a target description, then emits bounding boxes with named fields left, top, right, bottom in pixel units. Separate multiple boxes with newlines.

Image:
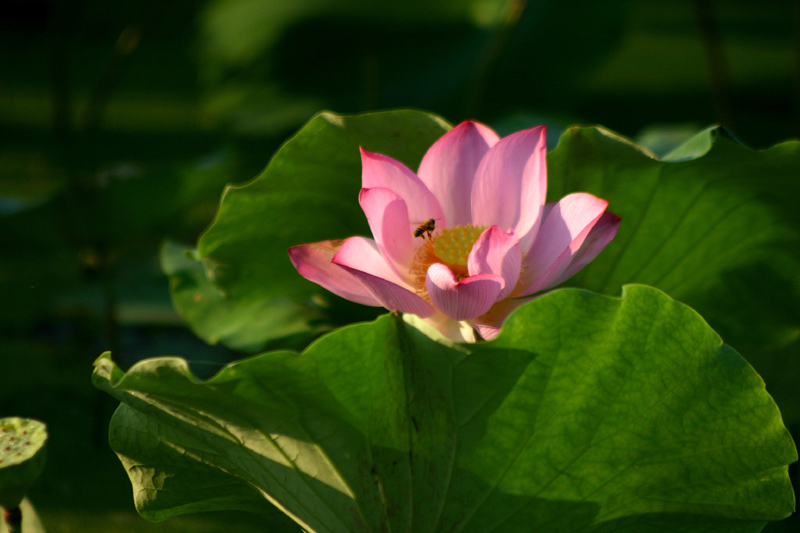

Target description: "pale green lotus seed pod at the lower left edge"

left=0, top=417, right=47, bottom=509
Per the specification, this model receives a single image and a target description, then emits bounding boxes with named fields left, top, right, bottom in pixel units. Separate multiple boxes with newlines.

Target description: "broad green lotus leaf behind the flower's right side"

left=547, top=123, right=800, bottom=355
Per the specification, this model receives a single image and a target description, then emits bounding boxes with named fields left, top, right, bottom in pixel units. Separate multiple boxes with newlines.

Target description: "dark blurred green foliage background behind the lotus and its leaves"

left=0, top=0, right=800, bottom=531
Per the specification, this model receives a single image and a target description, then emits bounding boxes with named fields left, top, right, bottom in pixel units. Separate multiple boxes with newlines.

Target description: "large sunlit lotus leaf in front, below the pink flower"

left=94, top=285, right=797, bottom=533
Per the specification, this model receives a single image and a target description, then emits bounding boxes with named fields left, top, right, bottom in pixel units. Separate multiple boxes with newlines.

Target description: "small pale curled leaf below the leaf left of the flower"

left=161, top=241, right=326, bottom=353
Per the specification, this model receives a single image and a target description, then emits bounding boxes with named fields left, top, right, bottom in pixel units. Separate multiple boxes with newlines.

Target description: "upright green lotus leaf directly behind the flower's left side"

left=198, top=110, right=449, bottom=303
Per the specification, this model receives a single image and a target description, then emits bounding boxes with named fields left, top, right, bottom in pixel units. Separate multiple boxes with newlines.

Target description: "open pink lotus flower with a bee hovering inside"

left=289, top=122, right=620, bottom=342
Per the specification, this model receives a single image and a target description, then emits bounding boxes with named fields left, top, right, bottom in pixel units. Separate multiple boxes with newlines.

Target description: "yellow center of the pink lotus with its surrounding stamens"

left=410, top=224, right=486, bottom=301
